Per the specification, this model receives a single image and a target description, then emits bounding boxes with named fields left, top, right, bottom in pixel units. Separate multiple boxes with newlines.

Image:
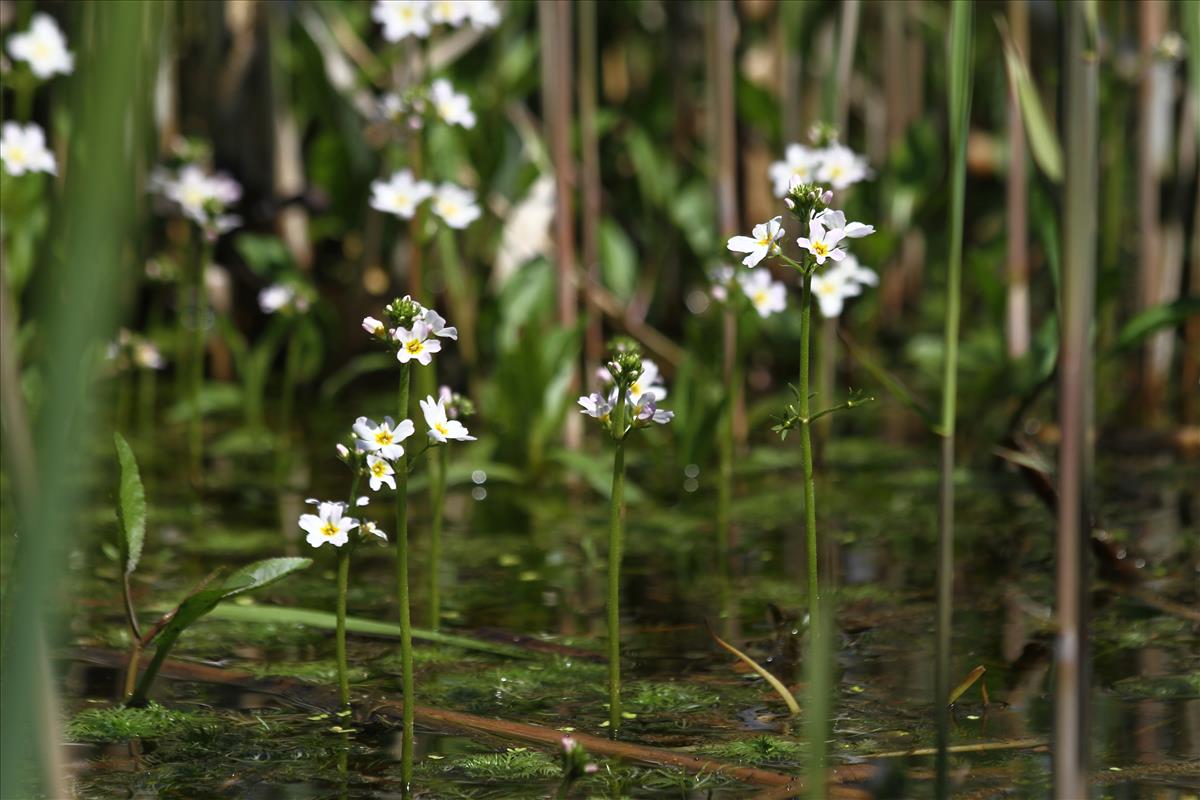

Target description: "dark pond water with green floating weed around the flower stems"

left=54, top=422, right=1200, bottom=799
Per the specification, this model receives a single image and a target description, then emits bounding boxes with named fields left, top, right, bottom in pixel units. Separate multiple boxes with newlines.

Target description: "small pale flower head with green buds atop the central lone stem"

left=578, top=342, right=674, bottom=431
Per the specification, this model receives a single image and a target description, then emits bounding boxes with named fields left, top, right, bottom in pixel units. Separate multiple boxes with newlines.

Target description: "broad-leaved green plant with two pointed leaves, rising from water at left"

left=113, top=433, right=312, bottom=706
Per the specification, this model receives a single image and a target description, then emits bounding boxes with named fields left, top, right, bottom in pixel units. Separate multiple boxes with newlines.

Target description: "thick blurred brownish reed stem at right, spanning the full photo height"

left=1052, top=4, right=1098, bottom=798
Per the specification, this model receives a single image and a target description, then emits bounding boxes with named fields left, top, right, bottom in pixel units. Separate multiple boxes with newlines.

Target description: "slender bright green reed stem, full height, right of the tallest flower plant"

left=934, top=2, right=973, bottom=798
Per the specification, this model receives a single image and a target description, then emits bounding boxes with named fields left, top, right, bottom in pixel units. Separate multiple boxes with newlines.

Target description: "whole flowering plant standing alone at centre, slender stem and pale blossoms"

left=578, top=339, right=674, bottom=735
